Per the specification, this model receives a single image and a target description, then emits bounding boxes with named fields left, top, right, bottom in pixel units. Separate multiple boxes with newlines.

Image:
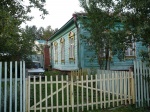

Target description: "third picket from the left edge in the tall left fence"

left=9, top=62, right=12, bottom=112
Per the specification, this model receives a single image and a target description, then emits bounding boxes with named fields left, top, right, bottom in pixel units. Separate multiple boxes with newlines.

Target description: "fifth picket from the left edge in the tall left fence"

left=20, top=61, right=23, bottom=112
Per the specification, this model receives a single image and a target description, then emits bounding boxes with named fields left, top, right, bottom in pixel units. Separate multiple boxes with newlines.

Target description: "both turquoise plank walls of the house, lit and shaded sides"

left=50, top=20, right=146, bottom=71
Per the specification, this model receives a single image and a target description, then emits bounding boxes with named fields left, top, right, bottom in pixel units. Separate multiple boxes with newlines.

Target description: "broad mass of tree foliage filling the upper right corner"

left=79, top=0, right=150, bottom=68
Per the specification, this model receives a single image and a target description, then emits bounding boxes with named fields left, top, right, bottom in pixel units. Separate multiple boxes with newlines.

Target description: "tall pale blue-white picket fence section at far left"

left=0, top=61, right=26, bottom=112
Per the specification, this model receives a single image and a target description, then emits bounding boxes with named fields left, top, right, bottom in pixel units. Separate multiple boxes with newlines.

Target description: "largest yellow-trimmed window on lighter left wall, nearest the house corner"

left=69, top=32, right=75, bottom=59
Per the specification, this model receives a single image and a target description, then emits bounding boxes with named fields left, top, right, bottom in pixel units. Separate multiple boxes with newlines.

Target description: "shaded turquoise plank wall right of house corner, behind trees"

left=80, top=21, right=147, bottom=70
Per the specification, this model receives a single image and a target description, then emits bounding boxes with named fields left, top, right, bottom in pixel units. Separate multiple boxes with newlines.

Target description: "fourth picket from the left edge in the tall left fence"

left=15, top=61, right=18, bottom=112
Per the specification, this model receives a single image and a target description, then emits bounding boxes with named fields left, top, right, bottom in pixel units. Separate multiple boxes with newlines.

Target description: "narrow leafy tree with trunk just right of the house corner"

left=81, top=1, right=115, bottom=69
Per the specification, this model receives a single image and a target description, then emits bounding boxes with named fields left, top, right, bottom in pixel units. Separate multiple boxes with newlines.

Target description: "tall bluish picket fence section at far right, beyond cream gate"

left=134, top=61, right=150, bottom=107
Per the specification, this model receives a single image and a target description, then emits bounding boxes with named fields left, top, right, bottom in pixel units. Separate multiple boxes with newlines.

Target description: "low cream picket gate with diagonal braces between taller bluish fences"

left=27, top=72, right=135, bottom=112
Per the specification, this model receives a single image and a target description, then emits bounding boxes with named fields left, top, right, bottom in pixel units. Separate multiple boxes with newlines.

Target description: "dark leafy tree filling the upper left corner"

left=0, top=0, right=48, bottom=61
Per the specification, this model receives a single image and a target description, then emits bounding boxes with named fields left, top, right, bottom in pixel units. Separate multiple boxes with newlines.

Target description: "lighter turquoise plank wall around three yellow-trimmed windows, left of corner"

left=51, top=24, right=78, bottom=71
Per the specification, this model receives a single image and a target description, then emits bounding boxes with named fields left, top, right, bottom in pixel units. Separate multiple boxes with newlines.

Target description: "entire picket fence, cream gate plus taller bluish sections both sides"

left=0, top=61, right=150, bottom=112
